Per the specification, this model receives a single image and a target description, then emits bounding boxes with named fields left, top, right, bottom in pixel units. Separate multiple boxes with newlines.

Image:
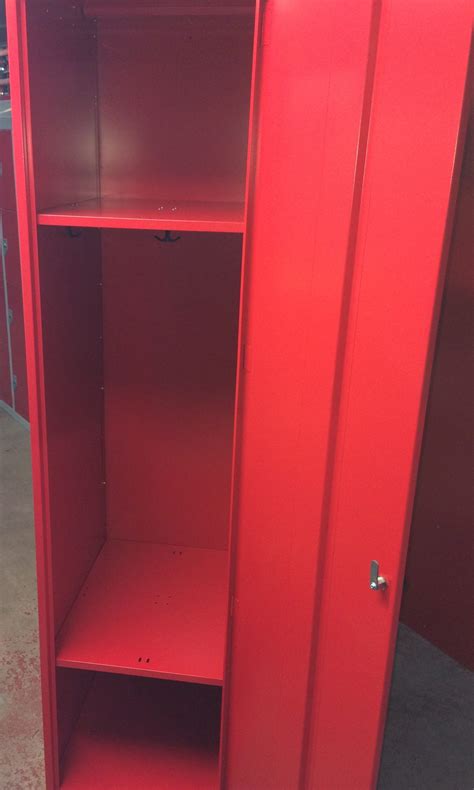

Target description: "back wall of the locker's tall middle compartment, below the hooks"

left=102, top=231, right=242, bottom=549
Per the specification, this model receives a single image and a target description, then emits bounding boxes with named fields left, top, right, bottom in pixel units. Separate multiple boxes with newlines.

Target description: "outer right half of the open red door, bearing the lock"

left=307, top=0, right=472, bottom=790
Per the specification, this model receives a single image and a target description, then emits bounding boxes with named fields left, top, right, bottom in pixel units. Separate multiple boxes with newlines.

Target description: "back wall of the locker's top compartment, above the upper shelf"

left=98, top=16, right=253, bottom=201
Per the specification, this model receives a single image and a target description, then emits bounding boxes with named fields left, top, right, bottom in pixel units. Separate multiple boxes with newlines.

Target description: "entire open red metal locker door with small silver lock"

left=224, top=0, right=471, bottom=790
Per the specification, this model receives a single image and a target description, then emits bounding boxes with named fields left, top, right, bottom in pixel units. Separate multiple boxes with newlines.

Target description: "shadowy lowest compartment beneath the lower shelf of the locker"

left=61, top=673, right=221, bottom=790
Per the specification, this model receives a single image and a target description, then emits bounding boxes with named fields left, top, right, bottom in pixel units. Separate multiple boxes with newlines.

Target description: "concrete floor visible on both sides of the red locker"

left=0, top=410, right=474, bottom=790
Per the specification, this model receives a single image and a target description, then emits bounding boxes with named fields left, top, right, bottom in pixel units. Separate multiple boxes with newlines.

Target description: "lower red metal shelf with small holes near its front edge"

left=56, top=540, right=227, bottom=685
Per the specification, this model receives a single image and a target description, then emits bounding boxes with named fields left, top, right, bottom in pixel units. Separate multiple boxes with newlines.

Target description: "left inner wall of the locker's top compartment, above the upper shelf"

left=24, top=0, right=98, bottom=209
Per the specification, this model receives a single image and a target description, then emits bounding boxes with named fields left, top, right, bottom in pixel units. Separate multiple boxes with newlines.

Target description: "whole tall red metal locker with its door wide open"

left=7, top=0, right=471, bottom=790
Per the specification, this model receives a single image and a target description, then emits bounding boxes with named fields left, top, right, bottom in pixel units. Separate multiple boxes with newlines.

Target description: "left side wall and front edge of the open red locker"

left=6, top=0, right=104, bottom=790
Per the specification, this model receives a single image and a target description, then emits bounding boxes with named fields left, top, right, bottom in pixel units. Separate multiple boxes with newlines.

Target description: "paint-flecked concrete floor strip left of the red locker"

left=0, top=409, right=44, bottom=790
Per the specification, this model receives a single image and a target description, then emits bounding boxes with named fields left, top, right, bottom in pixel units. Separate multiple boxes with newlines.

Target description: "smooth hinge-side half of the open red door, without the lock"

left=224, top=0, right=376, bottom=790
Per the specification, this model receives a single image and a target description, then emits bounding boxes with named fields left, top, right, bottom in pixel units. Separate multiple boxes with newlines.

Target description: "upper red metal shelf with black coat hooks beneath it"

left=38, top=197, right=244, bottom=235
